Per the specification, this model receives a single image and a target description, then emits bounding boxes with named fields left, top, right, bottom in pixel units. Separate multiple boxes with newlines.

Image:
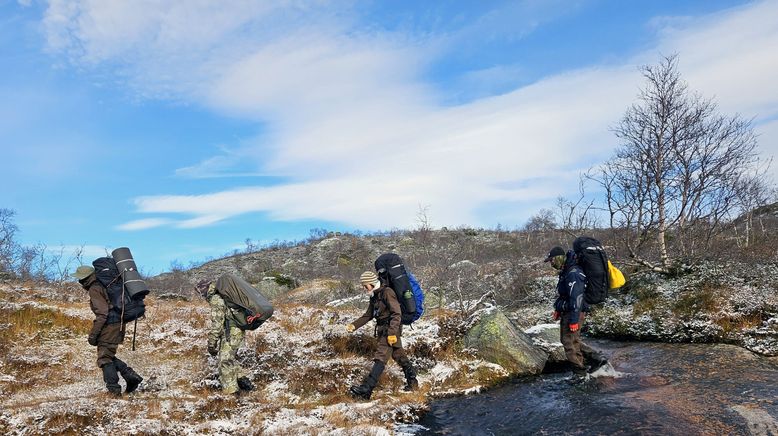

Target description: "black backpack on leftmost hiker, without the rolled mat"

left=92, top=257, right=148, bottom=324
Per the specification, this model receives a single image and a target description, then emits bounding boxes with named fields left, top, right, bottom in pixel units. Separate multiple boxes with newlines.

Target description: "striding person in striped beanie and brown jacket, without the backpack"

left=346, top=271, right=419, bottom=400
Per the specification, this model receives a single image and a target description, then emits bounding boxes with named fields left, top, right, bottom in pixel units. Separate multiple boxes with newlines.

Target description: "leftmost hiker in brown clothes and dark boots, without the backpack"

left=71, top=265, right=143, bottom=397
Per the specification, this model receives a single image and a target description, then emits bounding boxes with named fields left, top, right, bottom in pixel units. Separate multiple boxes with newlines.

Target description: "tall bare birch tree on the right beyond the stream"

left=593, top=55, right=760, bottom=272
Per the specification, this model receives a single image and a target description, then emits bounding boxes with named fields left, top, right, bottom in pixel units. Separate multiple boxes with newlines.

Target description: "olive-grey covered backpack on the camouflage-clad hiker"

left=216, top=274, right=273, bottom=330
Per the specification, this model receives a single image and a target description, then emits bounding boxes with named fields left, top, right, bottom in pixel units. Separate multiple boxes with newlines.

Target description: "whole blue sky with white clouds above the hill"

left=0, top=0, right=778, bottom=273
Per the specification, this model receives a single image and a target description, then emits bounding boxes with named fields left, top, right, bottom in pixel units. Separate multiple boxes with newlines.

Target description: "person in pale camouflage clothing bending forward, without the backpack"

left=196, top=280, right=254, bottom=396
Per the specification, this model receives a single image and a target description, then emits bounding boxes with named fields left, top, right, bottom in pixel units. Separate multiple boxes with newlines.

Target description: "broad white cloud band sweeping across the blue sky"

left=42, top=0, right=778, bottom=230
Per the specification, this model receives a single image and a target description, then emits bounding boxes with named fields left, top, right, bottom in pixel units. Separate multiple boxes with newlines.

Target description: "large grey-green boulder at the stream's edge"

left=464, top=308, right=548, bottom=375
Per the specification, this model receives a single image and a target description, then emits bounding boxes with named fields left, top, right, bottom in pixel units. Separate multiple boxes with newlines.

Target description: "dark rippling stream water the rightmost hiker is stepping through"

left=418, top=341, right=778, bottom=436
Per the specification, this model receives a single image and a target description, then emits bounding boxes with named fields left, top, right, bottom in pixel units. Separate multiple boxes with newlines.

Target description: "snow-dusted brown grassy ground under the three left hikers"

left=0, top=284, right=510, bottom=435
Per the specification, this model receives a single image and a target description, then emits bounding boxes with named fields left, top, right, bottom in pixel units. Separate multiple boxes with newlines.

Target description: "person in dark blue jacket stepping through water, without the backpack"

left=544, top=247, right=608, bottom=379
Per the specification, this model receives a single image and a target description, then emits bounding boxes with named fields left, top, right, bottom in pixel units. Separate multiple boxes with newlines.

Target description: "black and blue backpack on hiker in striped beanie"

left=375, top=253, right=424, bottom=325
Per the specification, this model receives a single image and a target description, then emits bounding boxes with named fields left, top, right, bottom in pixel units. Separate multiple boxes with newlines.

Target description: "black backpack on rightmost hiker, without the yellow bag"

left=573, top=236, right=610, bottom=304
